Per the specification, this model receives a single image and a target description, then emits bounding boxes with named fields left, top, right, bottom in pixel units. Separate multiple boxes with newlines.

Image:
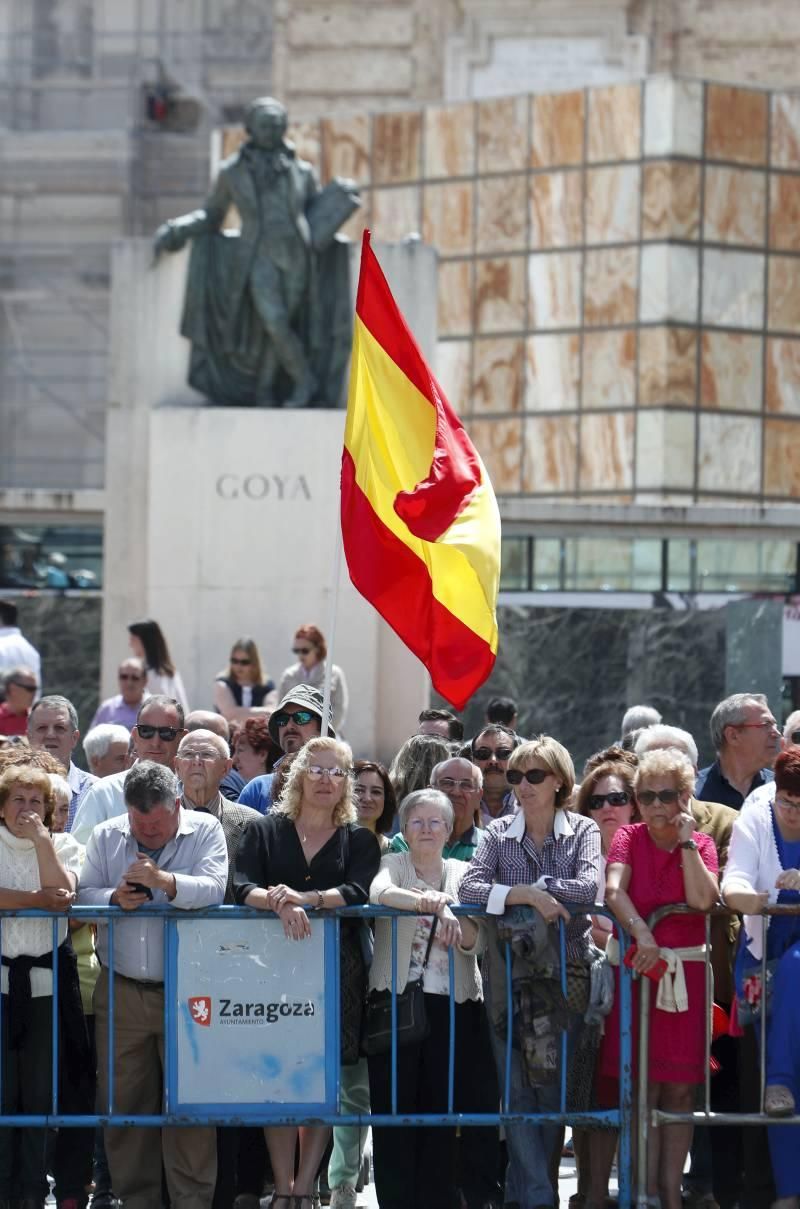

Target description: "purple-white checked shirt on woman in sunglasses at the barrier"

left=459, top=810, right=601, bottom=961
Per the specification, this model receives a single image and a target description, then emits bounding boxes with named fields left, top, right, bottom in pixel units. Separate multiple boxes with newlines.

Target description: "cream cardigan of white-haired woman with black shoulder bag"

left=370, top=852, right=483, bottom=1003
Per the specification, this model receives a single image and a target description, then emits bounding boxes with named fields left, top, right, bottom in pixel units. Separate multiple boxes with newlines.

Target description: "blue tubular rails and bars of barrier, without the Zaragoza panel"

left=0, top=904, right=633, bottom=1209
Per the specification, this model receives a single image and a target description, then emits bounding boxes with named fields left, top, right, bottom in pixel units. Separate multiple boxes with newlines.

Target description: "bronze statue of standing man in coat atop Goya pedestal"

left=155, top=97, right=361, bottom=407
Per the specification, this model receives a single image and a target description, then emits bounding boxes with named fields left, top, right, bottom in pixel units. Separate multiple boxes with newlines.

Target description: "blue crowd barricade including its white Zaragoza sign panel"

left=0, top=904, right=633, bottom=1209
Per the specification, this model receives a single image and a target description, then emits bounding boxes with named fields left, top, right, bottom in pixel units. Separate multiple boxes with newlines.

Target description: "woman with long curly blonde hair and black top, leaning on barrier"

left=234, top=737, right=381, bottom=1209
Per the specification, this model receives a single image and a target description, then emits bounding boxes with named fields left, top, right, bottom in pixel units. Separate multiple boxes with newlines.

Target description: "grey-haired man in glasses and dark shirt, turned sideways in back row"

left=695, top=693, right=781, bottom=810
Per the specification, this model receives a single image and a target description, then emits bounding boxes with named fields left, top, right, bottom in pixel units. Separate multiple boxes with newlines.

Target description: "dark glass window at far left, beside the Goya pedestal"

left=0, top=525, right=103, bottom=591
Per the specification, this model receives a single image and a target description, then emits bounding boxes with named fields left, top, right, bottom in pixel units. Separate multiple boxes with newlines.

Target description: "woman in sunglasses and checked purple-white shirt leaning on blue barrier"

left=459, top=735, right=601, bottom=1209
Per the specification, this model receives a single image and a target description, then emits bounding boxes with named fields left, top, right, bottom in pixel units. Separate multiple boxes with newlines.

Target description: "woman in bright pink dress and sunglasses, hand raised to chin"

left=599, top=748, right=718, bottom=1209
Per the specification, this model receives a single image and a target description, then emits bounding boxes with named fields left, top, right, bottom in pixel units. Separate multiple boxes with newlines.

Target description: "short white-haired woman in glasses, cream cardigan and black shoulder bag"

left=369, top=789, right=483, bottom=1209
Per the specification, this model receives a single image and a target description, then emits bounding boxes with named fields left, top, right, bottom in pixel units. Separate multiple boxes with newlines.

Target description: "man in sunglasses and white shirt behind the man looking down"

left=69, top=694, right=186, bottom=844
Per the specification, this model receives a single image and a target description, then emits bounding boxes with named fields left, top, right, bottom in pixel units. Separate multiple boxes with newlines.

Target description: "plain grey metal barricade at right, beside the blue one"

left=636, top=903, right=800, bottom=1209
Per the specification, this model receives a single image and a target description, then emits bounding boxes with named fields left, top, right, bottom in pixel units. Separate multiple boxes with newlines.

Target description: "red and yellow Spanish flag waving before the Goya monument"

left=342, top=231, right=500, bottom=710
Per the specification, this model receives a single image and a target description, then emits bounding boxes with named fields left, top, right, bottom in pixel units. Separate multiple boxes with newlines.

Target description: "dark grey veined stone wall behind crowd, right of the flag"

left=437, top=607, right=725, bottom=777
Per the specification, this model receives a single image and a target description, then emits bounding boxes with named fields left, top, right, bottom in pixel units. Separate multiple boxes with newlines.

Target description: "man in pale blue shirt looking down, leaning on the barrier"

left=77, top=759, right=228, bottom=1209
